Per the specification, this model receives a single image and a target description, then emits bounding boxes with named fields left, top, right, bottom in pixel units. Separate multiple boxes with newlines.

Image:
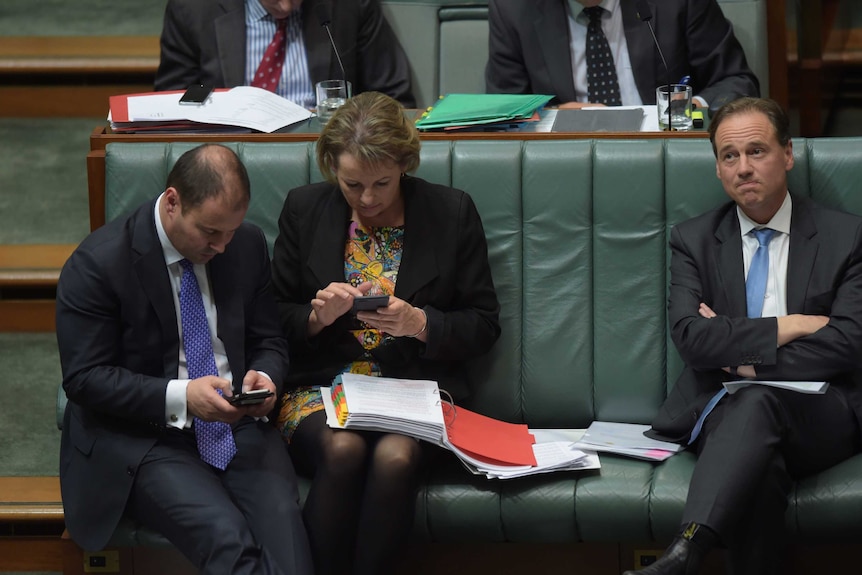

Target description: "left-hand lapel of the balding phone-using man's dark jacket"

left=132, top=203, right=180, bottom=377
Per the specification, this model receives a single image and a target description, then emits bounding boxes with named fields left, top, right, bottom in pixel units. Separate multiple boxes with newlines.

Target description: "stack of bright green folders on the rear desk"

left=416, top=94, right=553, bottom=130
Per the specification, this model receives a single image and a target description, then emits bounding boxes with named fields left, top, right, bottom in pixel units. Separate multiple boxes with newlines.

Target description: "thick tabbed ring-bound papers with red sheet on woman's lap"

left=320, top=374, right=598, bottom=479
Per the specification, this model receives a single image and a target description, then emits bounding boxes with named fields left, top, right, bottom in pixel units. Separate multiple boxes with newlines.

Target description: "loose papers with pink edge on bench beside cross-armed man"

left=575, top=421, right=682, bottom=461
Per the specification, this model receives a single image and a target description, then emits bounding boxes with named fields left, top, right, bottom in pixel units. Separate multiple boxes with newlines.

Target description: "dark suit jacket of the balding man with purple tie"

left=57, top=202, right=287, bottom=549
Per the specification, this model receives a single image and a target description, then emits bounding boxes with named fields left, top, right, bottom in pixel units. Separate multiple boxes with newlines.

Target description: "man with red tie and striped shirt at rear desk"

left=155, top=0, right=416, bottom=108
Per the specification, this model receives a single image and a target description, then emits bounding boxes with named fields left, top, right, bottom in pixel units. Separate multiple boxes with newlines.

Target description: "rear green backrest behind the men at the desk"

left=381, top=0, right=769, bottom=108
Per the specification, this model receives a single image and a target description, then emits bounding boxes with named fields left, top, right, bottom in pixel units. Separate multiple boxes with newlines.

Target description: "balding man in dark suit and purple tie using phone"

left=57, top=145, right=313, bottom=575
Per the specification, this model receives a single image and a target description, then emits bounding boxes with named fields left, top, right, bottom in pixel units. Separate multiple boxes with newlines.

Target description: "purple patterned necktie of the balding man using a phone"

left=180, top=259, right=236, bottom=470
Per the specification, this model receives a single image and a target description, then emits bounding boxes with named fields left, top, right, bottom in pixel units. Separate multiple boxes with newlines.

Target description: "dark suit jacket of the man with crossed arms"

left=653, top=196, right=862, bottom=439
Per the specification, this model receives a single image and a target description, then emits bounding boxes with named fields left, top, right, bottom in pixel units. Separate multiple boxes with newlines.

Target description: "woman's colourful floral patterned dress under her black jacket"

left=278, top=222, right=404, bottom=441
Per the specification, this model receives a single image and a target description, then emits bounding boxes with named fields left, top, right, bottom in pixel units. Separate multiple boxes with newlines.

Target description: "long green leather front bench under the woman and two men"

left=60, top=139, right=862, bottom=545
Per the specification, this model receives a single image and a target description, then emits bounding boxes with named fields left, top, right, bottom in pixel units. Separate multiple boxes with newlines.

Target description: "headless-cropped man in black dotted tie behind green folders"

left=485, top=0, right=760, bottom=113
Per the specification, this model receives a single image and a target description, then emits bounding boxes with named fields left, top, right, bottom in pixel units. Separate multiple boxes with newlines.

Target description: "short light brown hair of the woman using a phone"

left=317, top=92, right=421, bottom=182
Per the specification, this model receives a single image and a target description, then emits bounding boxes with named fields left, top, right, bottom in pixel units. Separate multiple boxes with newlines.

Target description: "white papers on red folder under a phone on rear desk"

left=108, top=86, right=313, bottom=133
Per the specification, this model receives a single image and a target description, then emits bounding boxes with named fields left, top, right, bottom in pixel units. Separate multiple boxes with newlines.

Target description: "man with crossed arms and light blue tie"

left=627, top=98, right=862, bottom=575
